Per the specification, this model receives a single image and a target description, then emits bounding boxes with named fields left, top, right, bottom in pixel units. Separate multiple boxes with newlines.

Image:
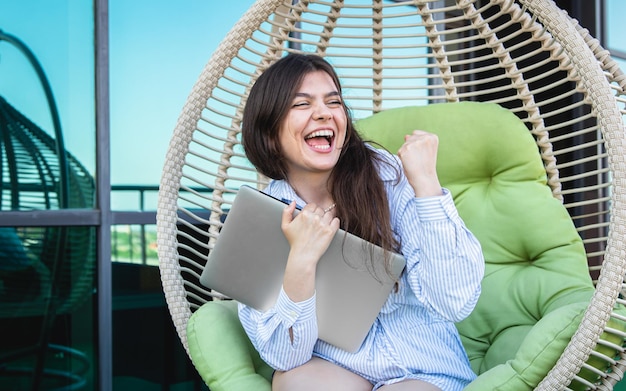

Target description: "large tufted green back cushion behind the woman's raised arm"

left=357, top=102, right=594, bottom=390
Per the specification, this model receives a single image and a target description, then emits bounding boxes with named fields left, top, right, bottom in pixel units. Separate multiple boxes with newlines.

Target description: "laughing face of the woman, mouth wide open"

left=279, top=71, right=346, bottom=178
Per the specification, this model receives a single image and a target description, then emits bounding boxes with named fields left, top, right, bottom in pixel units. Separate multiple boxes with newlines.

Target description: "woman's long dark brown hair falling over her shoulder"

left=242, top=54, right=398, bottom=258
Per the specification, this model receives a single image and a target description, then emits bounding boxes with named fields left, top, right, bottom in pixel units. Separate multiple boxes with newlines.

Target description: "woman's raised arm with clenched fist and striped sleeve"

left=398, top=130, right=484, bottom=321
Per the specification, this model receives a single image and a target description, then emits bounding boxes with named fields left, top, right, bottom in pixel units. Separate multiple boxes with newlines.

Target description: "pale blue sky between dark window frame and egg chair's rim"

left=109, top=0, right=253, bottom=188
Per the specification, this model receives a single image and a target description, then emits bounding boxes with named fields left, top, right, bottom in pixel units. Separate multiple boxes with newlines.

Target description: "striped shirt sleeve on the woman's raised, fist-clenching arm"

left=396, top=187, right=484, bottom=322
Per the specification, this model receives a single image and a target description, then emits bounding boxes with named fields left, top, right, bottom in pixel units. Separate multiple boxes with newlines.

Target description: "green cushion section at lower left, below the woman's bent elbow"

left=187, top=301, right=273, bottom=391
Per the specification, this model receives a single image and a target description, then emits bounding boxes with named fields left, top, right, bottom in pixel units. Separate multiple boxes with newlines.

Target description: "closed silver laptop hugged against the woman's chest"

left=200, top=186, right=405, bottom=352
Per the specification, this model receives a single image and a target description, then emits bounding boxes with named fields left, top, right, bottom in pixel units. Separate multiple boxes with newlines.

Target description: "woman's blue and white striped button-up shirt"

left=239, top=151, right=484, bottom=391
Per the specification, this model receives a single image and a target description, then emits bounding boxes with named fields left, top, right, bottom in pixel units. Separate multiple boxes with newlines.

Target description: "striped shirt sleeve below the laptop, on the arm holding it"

left=239, top=289, right=318, bottom=371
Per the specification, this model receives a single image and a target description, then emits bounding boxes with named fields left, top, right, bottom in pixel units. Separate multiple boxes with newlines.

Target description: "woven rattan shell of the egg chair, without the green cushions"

left=157, top=0, right=626, bottom=390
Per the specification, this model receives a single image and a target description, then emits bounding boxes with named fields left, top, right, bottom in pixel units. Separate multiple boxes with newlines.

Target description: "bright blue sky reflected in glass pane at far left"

left=0, top=0, right=94, bottom=167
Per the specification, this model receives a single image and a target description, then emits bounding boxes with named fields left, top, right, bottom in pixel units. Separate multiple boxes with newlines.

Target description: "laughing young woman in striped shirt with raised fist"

left=239, top=54, right=484, bottom=391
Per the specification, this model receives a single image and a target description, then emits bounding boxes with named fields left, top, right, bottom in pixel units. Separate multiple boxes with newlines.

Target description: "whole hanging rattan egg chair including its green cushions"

left=157, top=0, right=626, bottom=391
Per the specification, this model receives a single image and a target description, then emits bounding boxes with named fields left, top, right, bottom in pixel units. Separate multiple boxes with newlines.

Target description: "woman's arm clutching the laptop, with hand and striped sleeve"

left=239, top=188, right=339, bottom=371
